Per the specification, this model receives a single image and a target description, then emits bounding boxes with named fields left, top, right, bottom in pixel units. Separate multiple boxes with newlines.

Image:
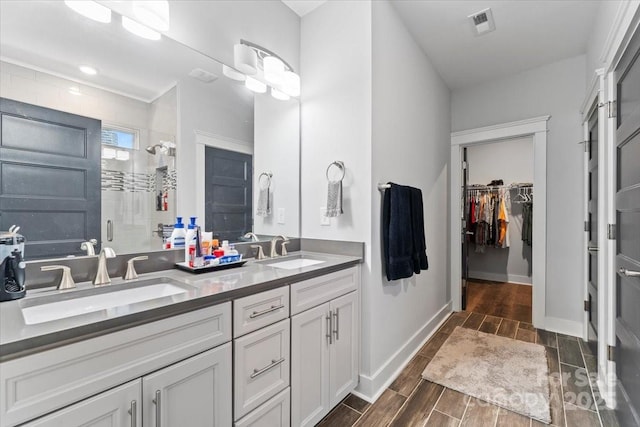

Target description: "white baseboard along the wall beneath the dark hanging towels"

left=352, top=301, right=452, bottom=403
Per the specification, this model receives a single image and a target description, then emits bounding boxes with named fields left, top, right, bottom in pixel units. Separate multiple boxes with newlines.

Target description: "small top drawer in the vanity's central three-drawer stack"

left=233, top=286, right=289, bottom=338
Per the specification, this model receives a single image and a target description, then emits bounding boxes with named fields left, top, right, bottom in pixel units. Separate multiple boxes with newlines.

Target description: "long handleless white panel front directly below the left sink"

left=0, top=302, right=231, bottom=427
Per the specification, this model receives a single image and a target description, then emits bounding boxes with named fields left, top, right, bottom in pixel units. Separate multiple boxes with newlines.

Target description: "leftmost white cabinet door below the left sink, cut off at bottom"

left=24, top=380, right=142, bottom=427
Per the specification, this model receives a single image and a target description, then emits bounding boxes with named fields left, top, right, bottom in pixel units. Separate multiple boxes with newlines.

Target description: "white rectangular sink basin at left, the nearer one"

left=22, top=283, right=187, bottom=325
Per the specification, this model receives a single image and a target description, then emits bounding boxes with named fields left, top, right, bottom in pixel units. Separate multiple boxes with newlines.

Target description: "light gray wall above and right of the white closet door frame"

left=451, top=55, right=586, bottom=330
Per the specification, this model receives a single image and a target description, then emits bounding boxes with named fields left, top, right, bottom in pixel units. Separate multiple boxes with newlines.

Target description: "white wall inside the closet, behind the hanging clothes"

left=467, top=137, right=535, bottom=284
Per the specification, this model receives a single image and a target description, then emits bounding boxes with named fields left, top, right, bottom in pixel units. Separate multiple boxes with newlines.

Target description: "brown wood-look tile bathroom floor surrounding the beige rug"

left=318, top=312, right=619, bottom=427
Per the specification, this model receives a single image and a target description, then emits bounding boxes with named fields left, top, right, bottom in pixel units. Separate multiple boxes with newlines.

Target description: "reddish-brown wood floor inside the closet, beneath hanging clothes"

left=467, top=279, right=532, bottom=323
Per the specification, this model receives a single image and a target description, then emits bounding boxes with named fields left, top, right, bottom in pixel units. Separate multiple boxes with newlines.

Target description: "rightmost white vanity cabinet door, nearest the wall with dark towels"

left=329, top=292, right=360, bottom=407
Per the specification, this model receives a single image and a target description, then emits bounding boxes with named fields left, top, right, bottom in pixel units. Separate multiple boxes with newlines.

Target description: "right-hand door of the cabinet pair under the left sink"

left=142, top=343, right=232, bottom=427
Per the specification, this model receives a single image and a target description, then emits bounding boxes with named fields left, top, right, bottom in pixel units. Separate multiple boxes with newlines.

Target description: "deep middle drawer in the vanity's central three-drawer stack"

left=233, top=319, right=290, bottom=421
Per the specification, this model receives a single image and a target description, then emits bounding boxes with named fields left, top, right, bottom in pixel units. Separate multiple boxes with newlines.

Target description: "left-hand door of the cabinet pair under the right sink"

left=291, top=303, right=330, bottom=426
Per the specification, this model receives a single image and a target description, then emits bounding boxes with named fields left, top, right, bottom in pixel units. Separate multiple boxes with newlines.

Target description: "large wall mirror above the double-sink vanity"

left=0, top=1, right=300, bottom=259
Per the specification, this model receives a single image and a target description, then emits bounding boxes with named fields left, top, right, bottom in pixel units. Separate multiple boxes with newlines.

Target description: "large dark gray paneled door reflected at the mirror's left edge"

left=0, top=98, right=101, bottom=259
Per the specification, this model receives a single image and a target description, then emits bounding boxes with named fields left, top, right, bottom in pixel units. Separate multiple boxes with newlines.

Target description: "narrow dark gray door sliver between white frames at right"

left=587, top=105, right=598, bottom=356
